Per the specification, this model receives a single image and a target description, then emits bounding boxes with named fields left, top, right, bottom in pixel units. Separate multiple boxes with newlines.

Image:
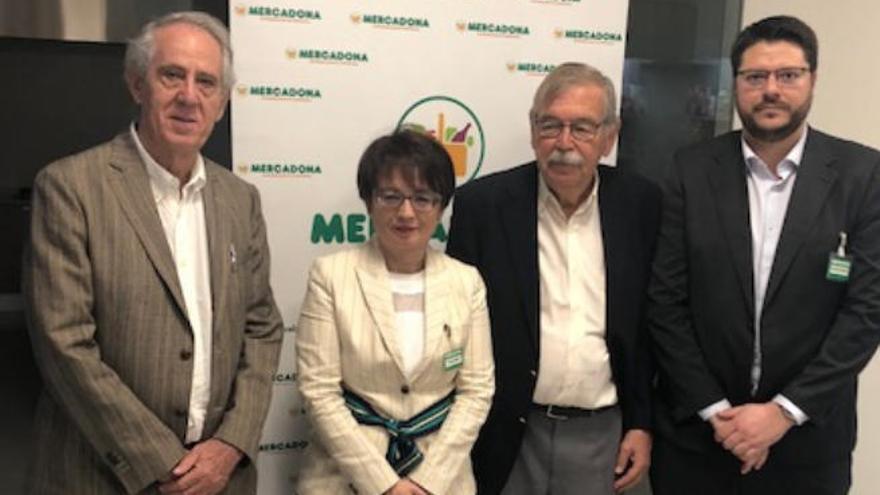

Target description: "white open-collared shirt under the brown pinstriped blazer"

left=131, top=124, right=213, bottom=443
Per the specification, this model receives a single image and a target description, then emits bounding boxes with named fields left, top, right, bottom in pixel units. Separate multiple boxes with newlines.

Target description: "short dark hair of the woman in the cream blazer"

left=357, top=129, right=455, bottom=209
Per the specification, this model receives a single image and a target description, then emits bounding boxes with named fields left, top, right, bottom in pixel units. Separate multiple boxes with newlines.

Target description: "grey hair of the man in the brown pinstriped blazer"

left=125, top=11, right=235, bottom=95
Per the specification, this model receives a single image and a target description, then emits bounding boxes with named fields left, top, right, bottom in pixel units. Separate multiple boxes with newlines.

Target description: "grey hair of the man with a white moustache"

left=529, top=62, right=617, bottom=124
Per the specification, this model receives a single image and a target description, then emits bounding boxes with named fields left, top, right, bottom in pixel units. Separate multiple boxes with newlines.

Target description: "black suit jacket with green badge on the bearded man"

left=649, top=130, right=880, bottom=466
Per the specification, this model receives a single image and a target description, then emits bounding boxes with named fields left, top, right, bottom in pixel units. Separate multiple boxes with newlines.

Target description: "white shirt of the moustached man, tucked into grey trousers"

left=532, top=174, right=617, bottom=409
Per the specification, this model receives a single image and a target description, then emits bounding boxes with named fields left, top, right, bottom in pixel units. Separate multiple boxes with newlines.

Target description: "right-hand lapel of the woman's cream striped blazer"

left=412, top=248, right=452, bottom=380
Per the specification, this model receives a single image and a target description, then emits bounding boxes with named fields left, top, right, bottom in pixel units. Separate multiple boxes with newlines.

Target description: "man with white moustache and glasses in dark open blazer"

left=447, top=63, right=660, bottom=495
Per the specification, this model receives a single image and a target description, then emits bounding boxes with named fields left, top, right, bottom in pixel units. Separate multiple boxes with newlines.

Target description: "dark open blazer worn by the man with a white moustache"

left=447, top=162, right=660, bottom=494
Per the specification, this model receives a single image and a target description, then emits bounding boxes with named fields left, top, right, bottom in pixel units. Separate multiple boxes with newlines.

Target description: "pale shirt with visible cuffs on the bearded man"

left=700, top=128, right=809, bottom=424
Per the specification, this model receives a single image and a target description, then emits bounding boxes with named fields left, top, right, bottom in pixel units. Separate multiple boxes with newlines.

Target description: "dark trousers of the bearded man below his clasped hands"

left=651, top=436, right=852, bottom=495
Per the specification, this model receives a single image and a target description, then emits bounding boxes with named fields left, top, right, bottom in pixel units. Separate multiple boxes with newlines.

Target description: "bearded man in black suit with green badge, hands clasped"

left=649, top=16, right=880, bottom=495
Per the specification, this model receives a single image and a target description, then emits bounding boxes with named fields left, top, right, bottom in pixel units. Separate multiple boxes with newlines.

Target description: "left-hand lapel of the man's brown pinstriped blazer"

left=110, top=134, right=186, bottom=315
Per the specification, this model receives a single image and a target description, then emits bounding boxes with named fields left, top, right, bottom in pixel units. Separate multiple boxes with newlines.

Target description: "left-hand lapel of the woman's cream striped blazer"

left=355, top=241, right=406, bottom=379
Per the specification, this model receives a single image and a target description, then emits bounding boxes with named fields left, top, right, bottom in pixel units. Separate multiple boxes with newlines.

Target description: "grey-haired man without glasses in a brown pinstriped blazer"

left=24, top=13, right=281, bottom=495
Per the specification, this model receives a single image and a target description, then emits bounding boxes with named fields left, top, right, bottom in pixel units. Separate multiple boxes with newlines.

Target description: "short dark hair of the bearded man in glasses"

left=730, top=15, right=819, bottom=74
